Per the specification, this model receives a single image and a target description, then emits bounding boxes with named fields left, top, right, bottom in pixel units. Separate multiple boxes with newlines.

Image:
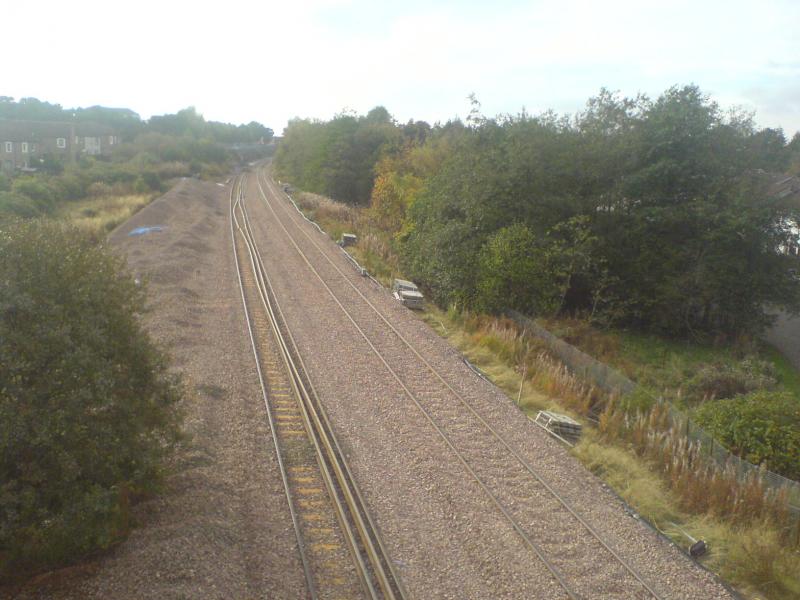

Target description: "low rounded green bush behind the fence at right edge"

left=695, top=391, right=800, bottom=479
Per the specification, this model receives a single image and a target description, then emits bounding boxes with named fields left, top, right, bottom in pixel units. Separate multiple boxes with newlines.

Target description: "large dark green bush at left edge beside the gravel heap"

left=0, top=221, right=180, bottom=579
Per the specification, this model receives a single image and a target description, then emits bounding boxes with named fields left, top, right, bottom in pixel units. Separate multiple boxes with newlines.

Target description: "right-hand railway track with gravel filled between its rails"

left=257, top=171, right=664, bottom=600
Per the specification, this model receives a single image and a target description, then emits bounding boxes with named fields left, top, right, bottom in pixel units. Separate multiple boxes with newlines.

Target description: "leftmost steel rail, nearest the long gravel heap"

left=229, top=176, right=318, bottom=600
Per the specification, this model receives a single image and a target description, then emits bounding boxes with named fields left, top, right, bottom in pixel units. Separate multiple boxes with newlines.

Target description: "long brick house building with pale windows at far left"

left=0, top=119, right=119, bottom=174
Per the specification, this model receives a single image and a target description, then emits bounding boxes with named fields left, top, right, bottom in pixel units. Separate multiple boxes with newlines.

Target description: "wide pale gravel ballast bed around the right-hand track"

left=248, top=171, right=731, bottom=598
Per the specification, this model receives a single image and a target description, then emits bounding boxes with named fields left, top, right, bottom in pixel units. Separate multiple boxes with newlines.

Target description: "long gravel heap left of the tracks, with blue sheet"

left=5, top=180, right=304, bottom=600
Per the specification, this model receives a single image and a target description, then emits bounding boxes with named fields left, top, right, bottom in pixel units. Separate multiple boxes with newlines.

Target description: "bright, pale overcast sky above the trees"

left=6, top=0, right=800, bottom=137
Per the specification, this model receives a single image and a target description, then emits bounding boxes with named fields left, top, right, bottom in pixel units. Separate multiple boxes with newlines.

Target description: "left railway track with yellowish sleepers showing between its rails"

left=230, top=175, right=406, bottom=600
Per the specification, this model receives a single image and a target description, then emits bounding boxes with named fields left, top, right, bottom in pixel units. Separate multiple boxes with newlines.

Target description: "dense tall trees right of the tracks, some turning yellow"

left=276, top=85, right=800, bottom=337
